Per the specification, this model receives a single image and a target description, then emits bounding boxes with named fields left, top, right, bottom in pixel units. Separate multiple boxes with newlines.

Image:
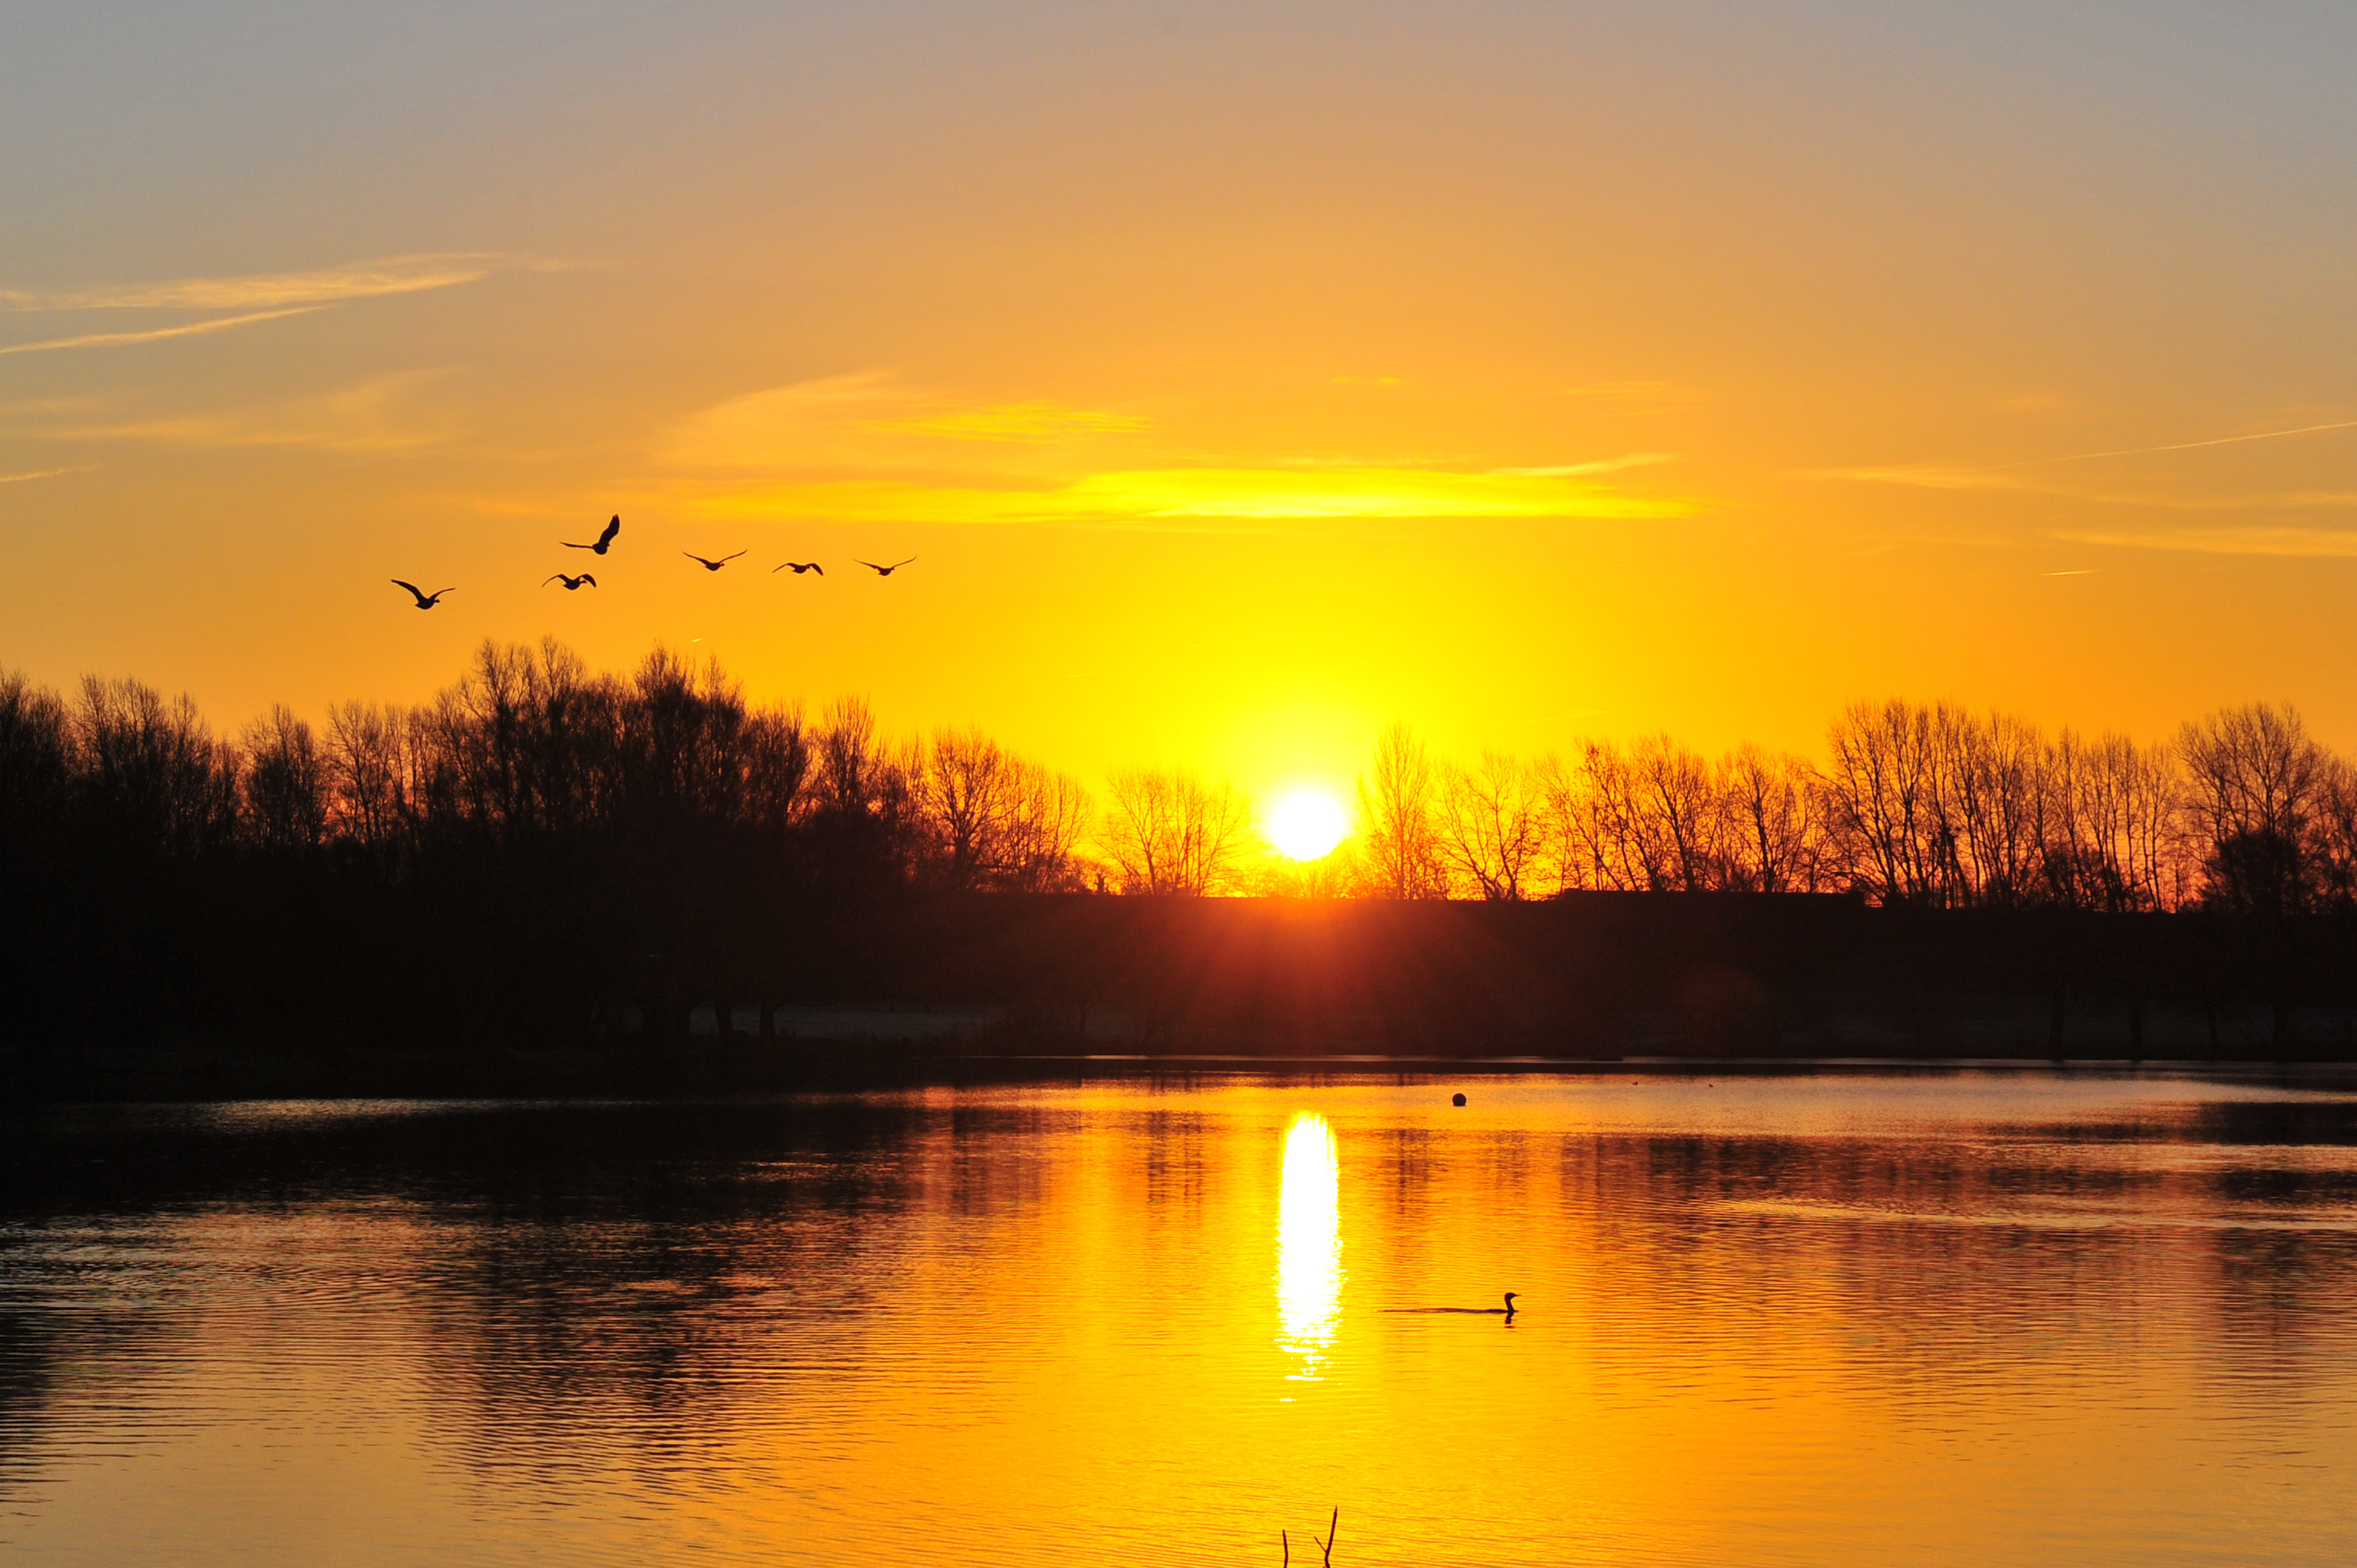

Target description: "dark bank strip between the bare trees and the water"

left=7, top=889, right=2357, bottom=1099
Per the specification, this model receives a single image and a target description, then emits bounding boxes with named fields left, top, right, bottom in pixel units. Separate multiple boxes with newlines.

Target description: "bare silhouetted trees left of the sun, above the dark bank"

left=0, top=639, right=1089, bottom=891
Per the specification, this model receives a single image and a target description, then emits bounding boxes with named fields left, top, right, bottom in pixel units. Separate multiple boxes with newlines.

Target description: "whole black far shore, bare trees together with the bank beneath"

left=0, top=641, right=2357, bottom=1075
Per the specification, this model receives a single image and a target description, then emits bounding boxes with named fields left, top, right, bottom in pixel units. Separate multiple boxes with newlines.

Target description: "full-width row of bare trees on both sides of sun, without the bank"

left=0, top=639, right=2357, bottom=917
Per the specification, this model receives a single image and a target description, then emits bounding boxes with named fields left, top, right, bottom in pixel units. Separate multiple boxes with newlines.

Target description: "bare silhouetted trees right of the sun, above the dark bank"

left=1355, top=700, right=2357, bottom=917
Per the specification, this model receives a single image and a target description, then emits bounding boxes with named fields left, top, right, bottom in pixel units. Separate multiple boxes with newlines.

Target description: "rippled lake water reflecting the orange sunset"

left=0, top=1073, right=2357, bottom=1568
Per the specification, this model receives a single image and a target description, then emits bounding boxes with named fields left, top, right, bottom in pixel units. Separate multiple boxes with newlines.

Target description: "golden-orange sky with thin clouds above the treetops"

left=0, top=2, right=2357, bottom=797
